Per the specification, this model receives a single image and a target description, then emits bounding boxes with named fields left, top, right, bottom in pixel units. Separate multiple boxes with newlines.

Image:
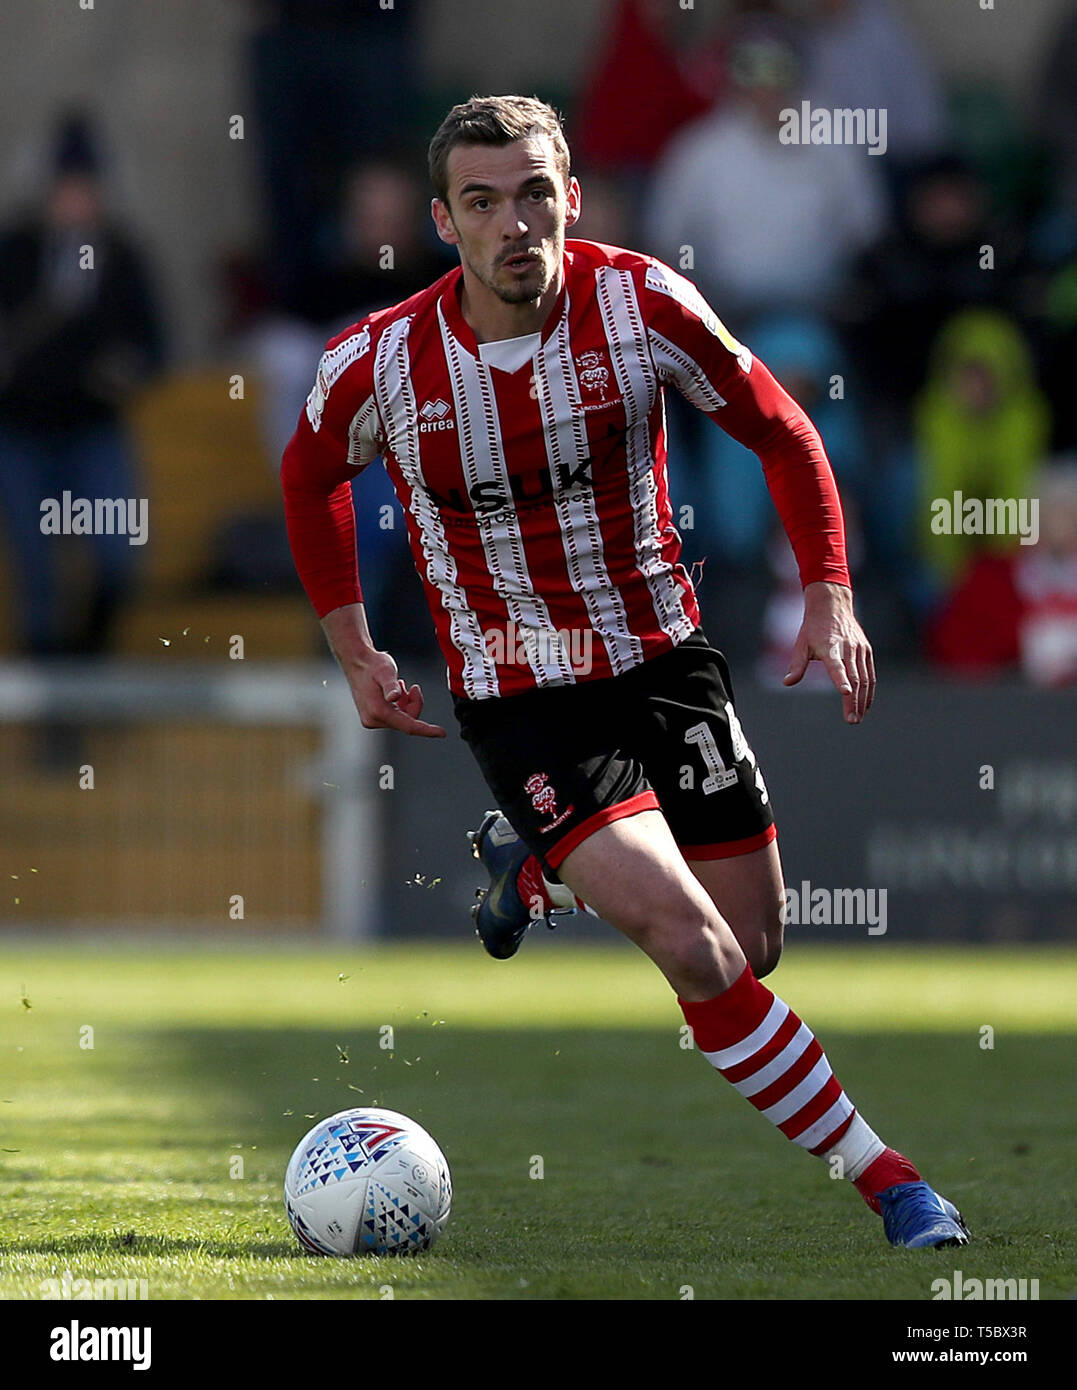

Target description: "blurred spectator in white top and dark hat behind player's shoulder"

left=646, top=21, right=885, bottom=323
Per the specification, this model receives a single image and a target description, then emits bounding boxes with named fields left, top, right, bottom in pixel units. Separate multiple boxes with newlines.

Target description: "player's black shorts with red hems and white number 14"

left=453, top=630, right=775, bottom=870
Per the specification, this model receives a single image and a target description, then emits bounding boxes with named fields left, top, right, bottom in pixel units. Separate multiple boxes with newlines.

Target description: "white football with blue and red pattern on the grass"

left=285, top=1106, right=453, bottom=1255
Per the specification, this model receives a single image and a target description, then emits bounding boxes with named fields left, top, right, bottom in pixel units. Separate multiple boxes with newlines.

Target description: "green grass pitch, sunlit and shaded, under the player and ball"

left=0, top=933, right=1077, bottom=1300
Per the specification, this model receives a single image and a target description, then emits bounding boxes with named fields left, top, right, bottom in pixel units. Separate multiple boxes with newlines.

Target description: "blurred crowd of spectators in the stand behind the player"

left=0, top=0, right=1077, bottom=685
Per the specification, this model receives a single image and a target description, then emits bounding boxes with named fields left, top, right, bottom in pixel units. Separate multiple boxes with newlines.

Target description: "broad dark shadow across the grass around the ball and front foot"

left=0, top=1023, right=1071, bottom=1297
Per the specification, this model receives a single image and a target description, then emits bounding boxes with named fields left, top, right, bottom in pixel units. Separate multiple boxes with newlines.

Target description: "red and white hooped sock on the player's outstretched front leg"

left=678, top=966, right=920, bottom=1211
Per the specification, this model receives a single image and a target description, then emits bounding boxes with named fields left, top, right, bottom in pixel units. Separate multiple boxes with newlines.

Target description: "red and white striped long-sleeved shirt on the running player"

left=281, top=240, right=849, bottom=699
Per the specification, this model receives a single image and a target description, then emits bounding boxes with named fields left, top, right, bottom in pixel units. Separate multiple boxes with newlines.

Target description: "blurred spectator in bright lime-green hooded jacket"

left=914, top=309, right=1051, bottom=588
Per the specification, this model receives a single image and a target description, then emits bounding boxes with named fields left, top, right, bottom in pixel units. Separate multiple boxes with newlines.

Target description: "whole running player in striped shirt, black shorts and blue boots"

left=282, top=96, right=967, bottom=1245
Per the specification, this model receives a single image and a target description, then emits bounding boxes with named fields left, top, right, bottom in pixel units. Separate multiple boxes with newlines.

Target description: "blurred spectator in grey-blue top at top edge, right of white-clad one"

left=787, top=0, right=948, bottom=175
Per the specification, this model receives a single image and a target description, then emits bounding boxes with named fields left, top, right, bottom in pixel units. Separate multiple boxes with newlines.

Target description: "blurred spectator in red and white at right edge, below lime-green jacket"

left=928, top=459, right=1077, bottom=687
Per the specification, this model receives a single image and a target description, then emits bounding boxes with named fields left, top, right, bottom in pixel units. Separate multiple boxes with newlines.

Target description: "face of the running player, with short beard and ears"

left=432, top=135, right=579, bottom=304
